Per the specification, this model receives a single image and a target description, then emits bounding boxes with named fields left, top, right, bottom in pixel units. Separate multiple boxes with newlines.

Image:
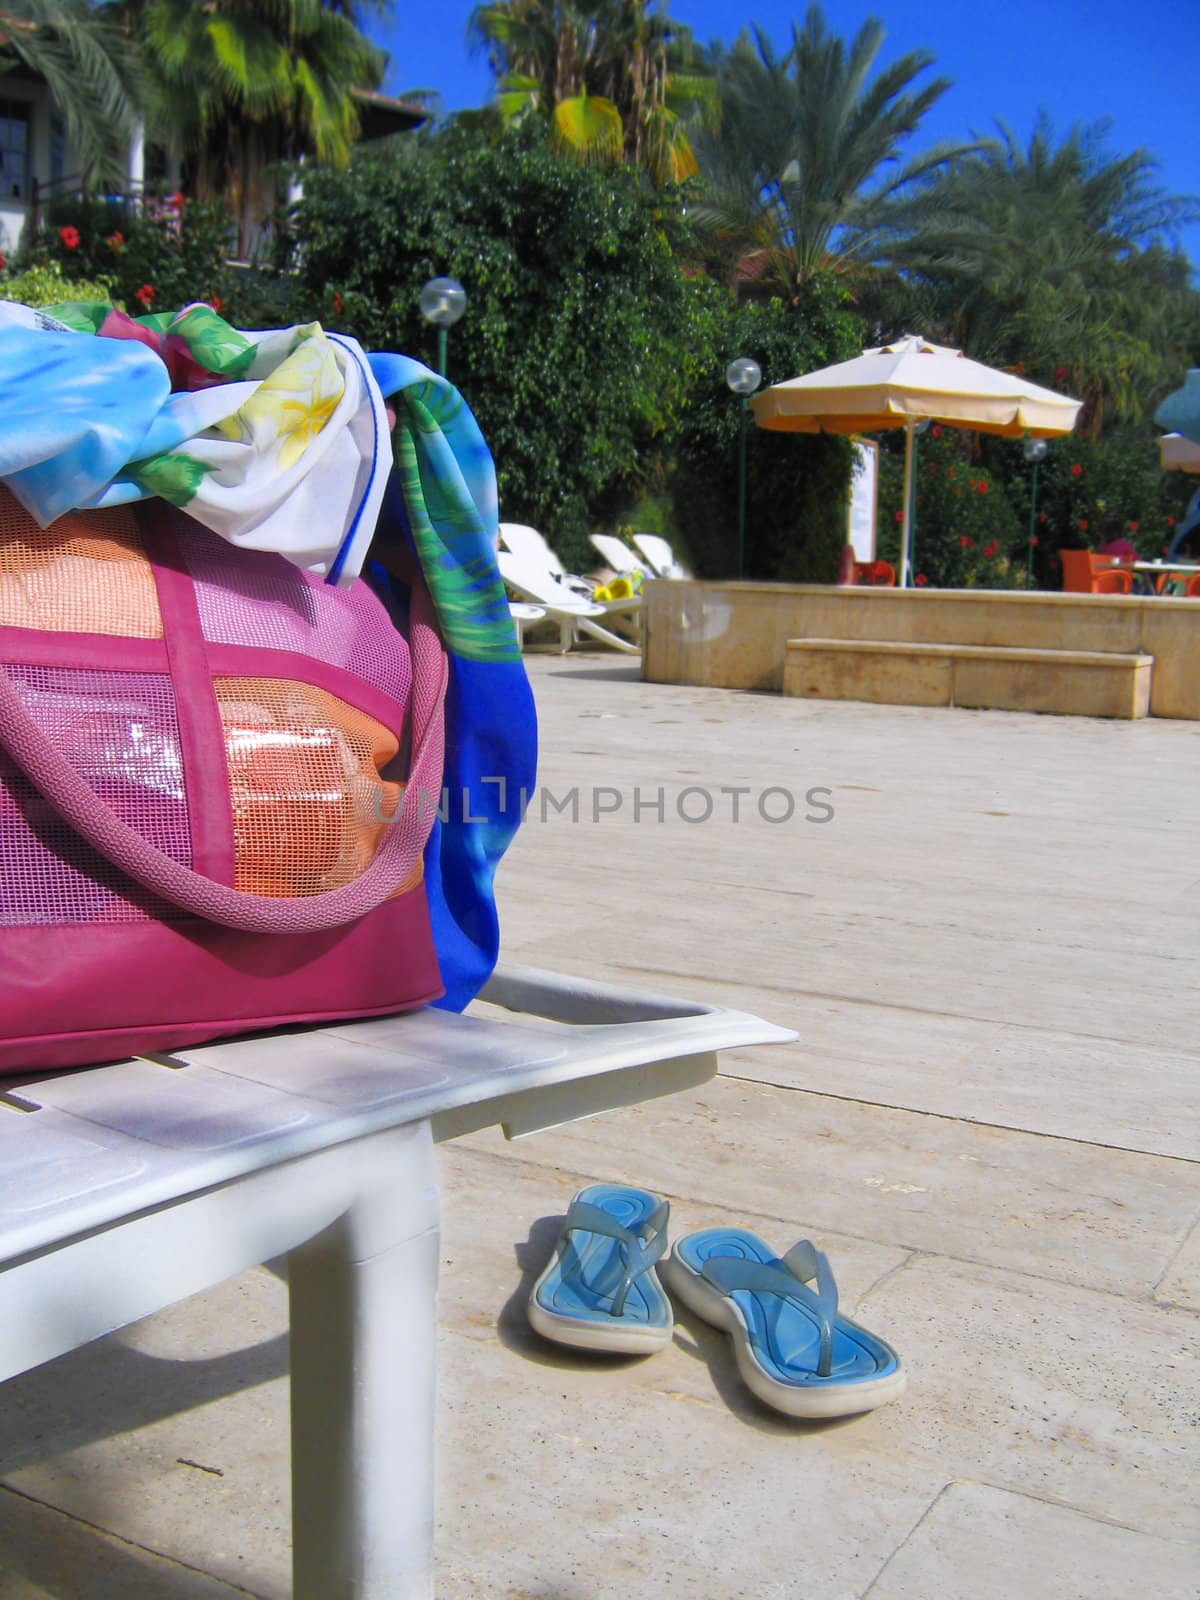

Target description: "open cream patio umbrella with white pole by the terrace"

left=750, top=334, right=1083, bottom=587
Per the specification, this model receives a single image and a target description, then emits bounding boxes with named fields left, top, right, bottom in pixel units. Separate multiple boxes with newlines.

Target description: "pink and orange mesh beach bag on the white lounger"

left=0, top=490, right=446, bottom=1072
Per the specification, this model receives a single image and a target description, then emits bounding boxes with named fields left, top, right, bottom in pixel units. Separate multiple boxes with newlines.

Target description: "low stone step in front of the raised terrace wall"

left=782, top=638, right=1154, bottom=718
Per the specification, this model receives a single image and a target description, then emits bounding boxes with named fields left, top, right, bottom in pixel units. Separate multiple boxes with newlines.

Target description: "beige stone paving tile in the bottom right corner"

left=866, top=1483, right=1200, bottom=1600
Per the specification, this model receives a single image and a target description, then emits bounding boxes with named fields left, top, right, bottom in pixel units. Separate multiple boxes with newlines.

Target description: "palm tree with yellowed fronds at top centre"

left=469, top=0, right=706, bottom=186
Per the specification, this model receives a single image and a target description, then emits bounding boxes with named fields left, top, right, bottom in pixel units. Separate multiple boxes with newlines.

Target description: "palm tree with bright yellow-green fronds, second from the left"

left=130, top=0, right=386, bottom=253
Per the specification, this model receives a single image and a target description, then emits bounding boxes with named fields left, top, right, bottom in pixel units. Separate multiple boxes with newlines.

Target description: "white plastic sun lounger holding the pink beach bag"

left=0, top=968, right=795, bottom=1600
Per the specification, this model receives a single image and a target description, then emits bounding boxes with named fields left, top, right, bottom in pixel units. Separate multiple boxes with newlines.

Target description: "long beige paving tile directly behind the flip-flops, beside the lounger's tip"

left=445, top=1058, right=1200, bottom=1296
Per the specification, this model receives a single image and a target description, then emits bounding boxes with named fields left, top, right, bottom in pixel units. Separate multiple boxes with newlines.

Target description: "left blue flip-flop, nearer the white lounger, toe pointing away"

left=528, top=1184, right=675, bottom=1355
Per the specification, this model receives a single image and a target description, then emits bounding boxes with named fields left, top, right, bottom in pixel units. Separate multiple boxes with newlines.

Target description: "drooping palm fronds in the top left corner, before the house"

left=0, top=0, right=141, bottom=182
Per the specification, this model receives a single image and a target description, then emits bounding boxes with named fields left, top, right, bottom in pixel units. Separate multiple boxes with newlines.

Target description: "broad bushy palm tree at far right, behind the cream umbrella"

left=886, top=114, right=1200, bottom=435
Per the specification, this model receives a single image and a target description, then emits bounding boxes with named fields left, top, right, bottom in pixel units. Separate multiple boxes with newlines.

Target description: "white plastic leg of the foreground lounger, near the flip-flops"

left=288, top=1122, right=440, bottom=1600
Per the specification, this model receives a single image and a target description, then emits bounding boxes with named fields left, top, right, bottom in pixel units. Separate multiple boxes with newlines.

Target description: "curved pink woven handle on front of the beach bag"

left=0, top=618, right=448, bottom=933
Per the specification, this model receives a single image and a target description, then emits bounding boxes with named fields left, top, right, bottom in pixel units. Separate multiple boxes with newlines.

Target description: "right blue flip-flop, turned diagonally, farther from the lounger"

left=662, top=1227, right=907, bottom=1418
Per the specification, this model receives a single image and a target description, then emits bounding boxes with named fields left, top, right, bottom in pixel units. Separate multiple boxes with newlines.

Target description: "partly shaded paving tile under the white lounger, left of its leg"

left=0, top=1270, right=291, bottom=1600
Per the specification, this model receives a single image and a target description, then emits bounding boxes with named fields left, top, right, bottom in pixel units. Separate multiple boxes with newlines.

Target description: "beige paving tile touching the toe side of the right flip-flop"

left=859, top=1258, right=1200, bottom=1541
